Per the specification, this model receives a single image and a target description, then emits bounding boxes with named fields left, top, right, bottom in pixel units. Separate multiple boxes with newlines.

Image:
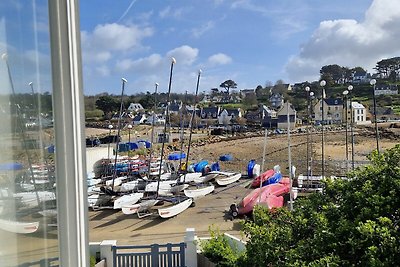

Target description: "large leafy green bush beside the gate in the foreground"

left=206, top=145, right=400, bottom=266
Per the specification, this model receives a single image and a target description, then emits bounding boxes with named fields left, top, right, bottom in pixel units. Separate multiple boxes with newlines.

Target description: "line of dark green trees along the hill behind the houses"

left=85, top=57, right=400, bottom=121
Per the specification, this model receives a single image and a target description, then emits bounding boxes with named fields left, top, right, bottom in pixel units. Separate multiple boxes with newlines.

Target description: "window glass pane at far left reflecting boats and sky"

left=0, top=0, right=58, bottom=266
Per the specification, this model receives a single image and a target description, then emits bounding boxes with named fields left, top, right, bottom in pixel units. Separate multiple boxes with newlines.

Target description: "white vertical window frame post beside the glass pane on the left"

left=48, top=0, right=89, bottom=267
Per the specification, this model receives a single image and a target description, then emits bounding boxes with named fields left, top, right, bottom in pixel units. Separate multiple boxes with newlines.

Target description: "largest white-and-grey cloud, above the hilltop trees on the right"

left=285, top=0, right=400, bottom=82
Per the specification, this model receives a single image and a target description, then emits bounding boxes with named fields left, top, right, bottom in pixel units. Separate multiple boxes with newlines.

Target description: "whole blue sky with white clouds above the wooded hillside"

left=0, top=0, right=400, bottom=95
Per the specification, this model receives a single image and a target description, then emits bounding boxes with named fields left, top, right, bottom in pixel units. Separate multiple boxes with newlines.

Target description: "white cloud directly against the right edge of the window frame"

left=81, top=23, right=154, bottom=62
